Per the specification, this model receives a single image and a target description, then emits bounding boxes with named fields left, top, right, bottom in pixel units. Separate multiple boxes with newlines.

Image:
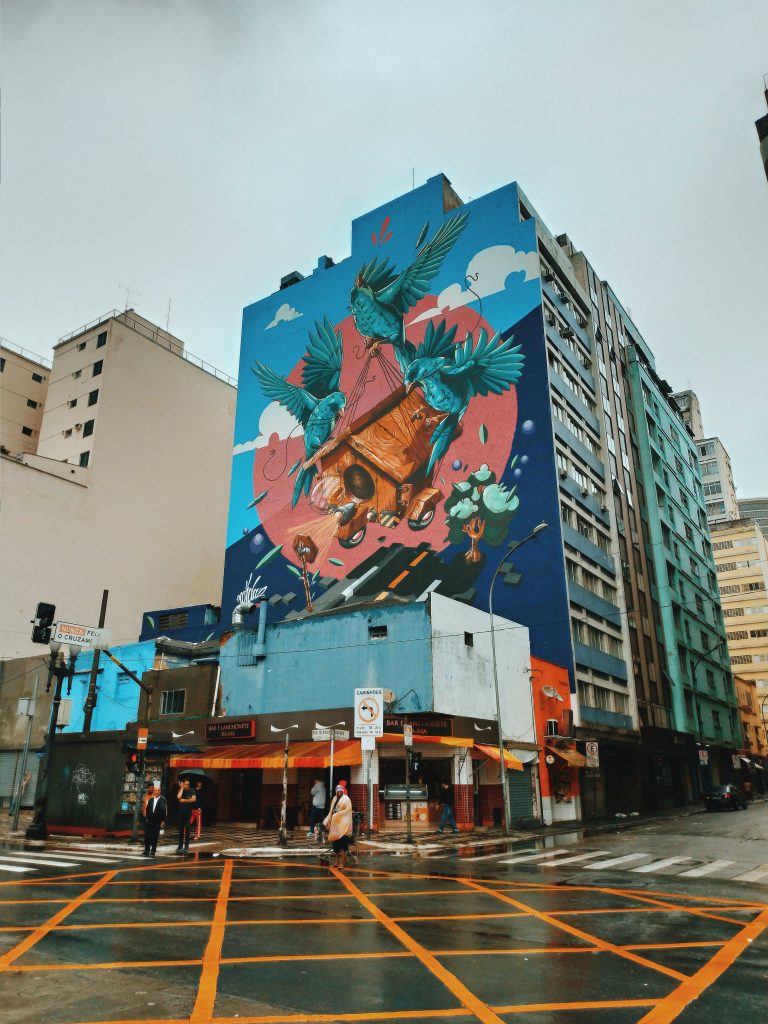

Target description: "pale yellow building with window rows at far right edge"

left=712, top=519, right=768, bottom=711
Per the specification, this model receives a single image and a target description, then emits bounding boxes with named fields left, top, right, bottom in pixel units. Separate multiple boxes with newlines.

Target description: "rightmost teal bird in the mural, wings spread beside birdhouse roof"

left=403, top=328, right=525, bottom=472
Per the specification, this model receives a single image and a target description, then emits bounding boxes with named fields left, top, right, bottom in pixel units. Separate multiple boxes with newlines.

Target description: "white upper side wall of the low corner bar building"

left=430, top=593, right=536, bottom=742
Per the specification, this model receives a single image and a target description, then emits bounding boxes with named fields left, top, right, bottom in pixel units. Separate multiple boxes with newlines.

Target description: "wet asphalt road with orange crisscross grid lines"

left=0, top=805, right=768, bottom=1024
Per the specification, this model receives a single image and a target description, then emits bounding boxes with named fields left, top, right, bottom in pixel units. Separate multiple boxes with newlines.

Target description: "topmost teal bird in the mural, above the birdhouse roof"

left=349, top=212, right=469, bottom=373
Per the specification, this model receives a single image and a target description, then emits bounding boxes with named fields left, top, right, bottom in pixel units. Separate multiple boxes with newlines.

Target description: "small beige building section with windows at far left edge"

left=0, top=338, right=50, bottom=452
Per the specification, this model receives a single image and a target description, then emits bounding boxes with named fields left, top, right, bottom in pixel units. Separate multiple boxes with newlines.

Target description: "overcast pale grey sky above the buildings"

left=0, top=0, right=768, bottom=497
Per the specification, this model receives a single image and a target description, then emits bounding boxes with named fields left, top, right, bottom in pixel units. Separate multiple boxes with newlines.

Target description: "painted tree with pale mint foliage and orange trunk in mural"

left=444, top=464, right=520, bottom=562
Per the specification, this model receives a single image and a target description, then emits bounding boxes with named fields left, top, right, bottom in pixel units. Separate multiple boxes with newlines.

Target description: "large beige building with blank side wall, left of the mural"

left=0, top=310, right=236, bottom=658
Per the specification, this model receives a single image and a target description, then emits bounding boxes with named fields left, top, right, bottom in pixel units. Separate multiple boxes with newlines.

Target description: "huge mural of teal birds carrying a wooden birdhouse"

left=222, top=179, right=569, bottom=679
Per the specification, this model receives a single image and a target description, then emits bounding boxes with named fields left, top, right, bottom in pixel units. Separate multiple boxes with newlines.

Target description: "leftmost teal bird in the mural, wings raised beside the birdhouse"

left=251, top=316, right=346, bottom=507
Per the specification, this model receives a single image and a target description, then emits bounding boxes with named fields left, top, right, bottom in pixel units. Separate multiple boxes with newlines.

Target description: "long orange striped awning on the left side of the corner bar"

left=170, top=739, right=362, bottom=768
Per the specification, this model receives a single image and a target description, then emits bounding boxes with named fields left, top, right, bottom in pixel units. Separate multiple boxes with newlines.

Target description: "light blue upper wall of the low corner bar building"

left=220, top=602, right=432, bottom=724
